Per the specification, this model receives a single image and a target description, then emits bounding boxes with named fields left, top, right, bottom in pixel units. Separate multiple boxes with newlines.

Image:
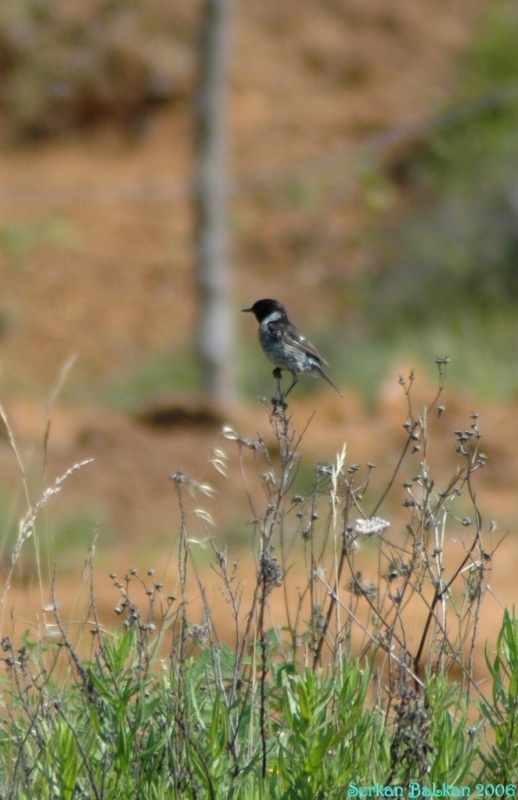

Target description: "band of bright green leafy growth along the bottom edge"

left=0, top=613, right=518, bottom=800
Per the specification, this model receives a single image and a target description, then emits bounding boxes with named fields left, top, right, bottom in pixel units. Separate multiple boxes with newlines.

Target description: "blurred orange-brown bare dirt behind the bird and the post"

left=0, top=0, right=518, bottom=676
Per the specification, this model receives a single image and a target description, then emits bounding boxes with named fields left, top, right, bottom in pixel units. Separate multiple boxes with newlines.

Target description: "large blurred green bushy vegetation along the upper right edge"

left=360, top=3, right=518, bottom=398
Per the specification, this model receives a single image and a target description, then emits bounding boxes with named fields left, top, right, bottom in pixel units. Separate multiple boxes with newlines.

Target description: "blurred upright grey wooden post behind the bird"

left=194, top=0, right=235, bottom=402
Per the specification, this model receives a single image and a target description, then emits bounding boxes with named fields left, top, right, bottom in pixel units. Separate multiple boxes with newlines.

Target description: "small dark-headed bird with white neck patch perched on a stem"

left=243, top=299, right=343, bottom=397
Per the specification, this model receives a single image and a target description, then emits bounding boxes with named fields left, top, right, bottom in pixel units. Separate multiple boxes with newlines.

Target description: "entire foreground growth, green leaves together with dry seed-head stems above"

left=0, top=359, right=518, bottom=800
